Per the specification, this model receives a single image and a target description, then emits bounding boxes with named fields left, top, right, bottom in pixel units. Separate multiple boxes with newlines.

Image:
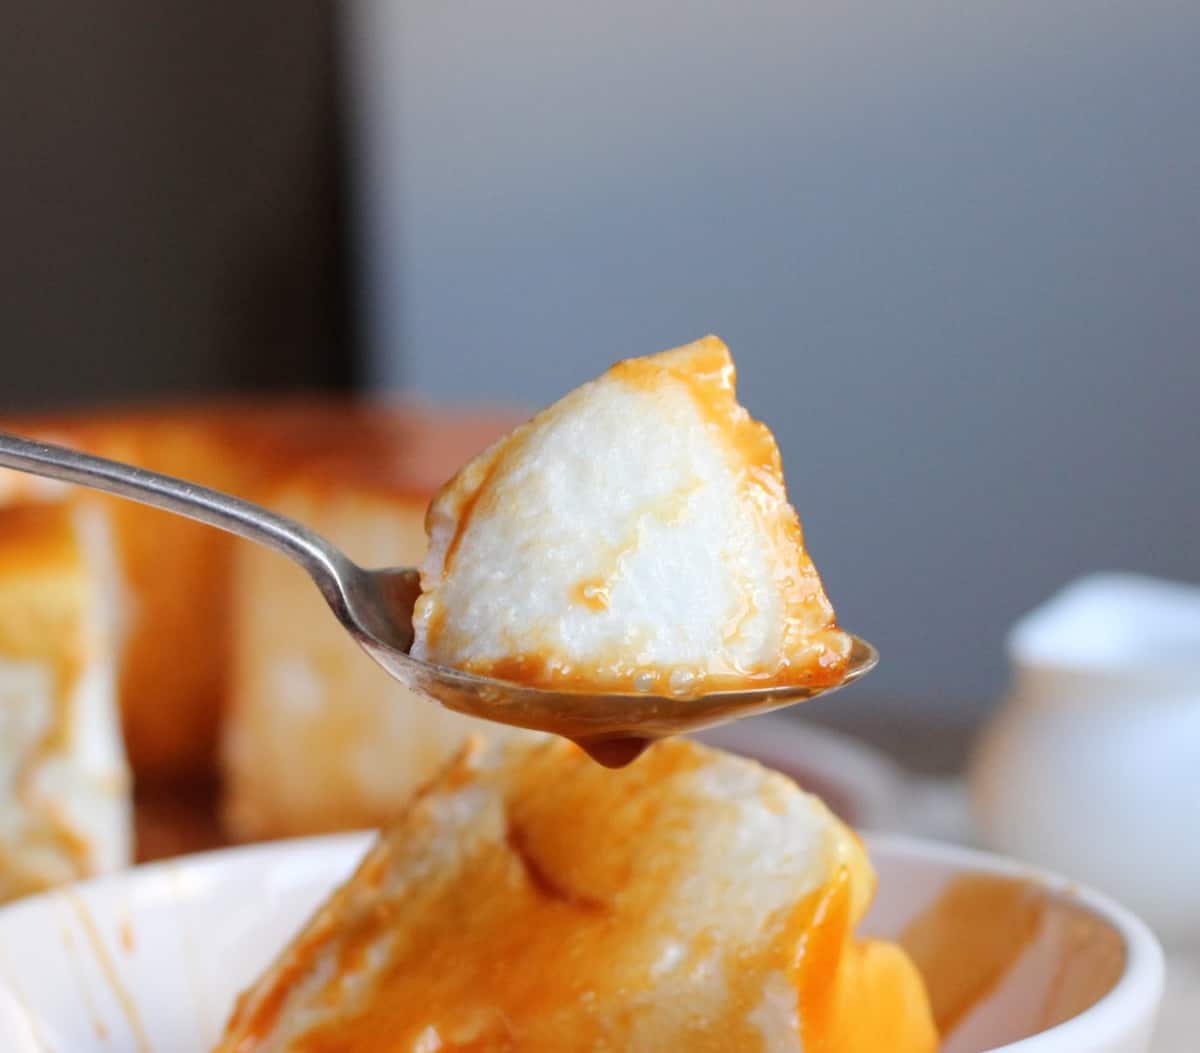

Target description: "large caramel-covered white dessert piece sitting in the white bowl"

left=217, top=740, right=936, bottom=1053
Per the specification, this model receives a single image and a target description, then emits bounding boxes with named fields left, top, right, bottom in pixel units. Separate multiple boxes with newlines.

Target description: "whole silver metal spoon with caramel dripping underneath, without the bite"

left=0, top=433, right=878, bottom=766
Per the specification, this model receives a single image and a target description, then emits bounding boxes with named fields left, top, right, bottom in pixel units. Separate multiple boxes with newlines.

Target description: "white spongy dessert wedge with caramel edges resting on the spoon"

left=413, top=337, right=851, bottom=694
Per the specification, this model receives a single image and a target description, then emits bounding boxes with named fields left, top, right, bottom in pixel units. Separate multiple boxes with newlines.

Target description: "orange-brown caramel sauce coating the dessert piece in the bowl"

left=220, top=742, right=936, bottom=1053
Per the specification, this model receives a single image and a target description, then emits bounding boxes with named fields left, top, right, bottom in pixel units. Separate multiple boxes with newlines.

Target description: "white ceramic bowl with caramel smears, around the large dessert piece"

left=0, top=835, right=1162, bottom=1053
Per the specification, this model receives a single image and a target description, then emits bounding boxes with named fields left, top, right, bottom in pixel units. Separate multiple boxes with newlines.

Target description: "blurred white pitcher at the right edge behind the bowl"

left=971, top=574, right=1200, bottom=946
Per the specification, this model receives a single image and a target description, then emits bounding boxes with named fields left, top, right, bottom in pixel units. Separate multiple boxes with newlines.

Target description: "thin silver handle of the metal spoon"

left=0, top=432, right=356, bottom=614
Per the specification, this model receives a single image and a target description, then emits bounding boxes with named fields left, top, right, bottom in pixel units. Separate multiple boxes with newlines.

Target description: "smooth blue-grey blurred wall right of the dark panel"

left=349, top=0, right=1200, bottom=727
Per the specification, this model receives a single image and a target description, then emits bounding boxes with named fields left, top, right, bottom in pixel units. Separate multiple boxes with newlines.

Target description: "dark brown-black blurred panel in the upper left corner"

left=0, top=0, right=354, bottom=410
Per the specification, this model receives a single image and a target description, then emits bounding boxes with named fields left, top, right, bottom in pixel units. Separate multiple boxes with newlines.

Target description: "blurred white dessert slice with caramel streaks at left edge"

left=0, top=503, right=131, bottom=899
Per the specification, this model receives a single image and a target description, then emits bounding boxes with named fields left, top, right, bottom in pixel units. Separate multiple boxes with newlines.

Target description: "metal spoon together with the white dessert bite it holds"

left=0, top=337, right=876, bottom=765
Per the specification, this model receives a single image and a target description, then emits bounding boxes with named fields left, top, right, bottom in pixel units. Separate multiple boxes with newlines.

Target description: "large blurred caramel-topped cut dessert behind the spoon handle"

left=0, top=397, right=535, bottom=858
